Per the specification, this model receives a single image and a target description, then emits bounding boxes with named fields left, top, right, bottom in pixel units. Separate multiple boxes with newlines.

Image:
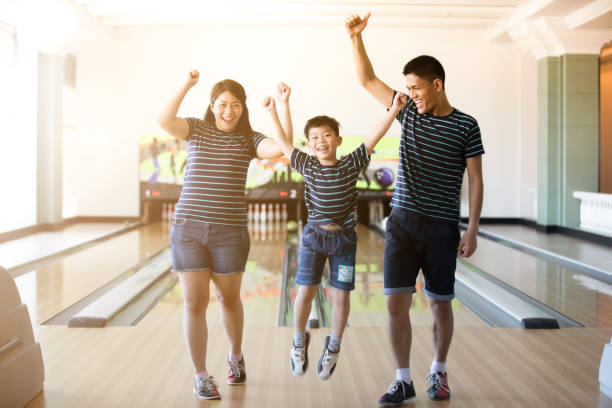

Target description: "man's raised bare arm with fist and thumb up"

left=344, top=13, right=393, bottom=108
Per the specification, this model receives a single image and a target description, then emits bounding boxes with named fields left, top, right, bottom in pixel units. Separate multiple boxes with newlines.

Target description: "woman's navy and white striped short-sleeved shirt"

left=175, top=118, right=265, bottom=226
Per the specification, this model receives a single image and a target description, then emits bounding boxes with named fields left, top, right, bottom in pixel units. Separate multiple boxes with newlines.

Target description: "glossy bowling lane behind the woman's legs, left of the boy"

left=138, top=222, right=286, bottom=328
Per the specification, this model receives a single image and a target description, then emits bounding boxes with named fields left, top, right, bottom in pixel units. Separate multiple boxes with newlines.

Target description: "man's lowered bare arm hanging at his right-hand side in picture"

left=457, top=156, right=484, bottom=258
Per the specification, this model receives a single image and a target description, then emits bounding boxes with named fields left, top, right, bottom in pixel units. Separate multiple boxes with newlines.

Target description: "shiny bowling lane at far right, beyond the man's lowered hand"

left=466, top=238, right=612, bottom=327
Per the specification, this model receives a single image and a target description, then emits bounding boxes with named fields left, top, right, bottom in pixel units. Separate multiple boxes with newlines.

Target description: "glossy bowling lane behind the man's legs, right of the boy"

left=349, top=225, right=487, bottom=327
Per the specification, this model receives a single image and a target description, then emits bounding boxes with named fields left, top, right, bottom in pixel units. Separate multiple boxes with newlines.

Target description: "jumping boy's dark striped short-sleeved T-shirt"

left=291, top=143, right=370, bottom=229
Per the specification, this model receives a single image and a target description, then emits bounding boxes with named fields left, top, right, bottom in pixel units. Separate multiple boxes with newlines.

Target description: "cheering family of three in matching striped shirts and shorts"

left=159, top=14, right=484, bottom=406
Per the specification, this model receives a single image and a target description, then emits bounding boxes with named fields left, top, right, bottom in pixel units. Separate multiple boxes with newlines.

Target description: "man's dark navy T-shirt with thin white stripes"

left=391, top=95, right=484, bottom=222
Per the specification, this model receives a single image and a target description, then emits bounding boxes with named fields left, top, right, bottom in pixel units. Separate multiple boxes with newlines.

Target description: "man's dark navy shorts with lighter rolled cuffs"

left=383, top=208, right=460, bottom=300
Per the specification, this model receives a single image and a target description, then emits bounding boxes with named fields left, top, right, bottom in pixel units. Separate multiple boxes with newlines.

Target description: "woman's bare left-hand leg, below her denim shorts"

left=179, top=270, right=210, bottom=372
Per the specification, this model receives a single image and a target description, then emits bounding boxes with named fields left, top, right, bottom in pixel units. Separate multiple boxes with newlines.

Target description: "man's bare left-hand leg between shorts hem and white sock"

left=387, top=292, right=412, bottom=368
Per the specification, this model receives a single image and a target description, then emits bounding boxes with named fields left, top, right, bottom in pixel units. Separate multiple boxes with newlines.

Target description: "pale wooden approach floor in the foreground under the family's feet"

left=28, top=326, right=612, bottom=408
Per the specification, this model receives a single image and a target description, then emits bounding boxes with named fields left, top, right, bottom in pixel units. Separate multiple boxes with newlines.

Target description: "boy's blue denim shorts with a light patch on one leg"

left=295, top=224, right=357, bottom=290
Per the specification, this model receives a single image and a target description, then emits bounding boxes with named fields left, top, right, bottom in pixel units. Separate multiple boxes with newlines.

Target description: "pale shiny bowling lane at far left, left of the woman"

left=15, top=222, right=169, bottom=324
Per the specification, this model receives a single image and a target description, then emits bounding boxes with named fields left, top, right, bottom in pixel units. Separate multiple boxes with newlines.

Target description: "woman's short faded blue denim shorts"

left=170, top=218, right=251, bottom=275
